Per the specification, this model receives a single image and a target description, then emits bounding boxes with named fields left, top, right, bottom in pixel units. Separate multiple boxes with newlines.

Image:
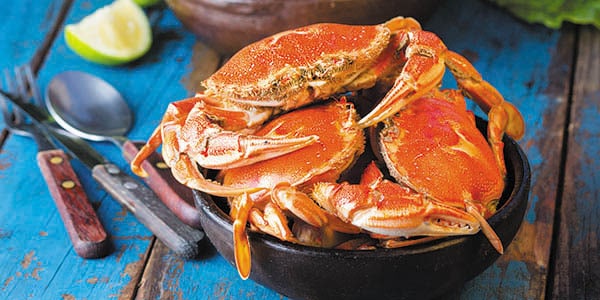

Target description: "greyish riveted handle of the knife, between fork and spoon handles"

left=92, top=163, right=204, bottom=258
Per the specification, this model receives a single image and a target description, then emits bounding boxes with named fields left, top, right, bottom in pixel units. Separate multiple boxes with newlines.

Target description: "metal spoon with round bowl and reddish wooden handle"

left=46, top=71, right=200, bottom=228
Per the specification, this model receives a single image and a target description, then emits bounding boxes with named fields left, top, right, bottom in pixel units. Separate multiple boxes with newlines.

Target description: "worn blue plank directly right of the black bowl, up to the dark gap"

left=425, top=1, right=574, bottom=299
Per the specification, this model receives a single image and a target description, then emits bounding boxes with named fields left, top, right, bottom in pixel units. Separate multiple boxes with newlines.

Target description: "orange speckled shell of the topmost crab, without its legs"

left=203, top=24, right=391, bottom=110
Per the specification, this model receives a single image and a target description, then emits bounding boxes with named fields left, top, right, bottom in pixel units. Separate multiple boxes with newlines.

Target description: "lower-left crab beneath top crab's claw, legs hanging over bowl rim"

left=217, top=100, right=365, bottom=279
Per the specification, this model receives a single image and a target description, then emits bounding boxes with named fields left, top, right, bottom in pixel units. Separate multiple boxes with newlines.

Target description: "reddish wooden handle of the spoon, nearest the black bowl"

left=123, top=141, right=201, bottom=229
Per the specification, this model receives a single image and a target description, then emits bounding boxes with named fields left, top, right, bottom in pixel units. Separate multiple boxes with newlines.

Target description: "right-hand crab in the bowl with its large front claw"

left=313, top=90, right=506, bottom=253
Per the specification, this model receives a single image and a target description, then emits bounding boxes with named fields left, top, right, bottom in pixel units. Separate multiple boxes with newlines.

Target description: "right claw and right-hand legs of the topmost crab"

left=359, top=32, right=525, bottom=170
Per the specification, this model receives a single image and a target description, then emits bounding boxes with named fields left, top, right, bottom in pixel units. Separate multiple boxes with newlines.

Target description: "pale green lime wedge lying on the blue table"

left=65, top=0, right=152, bottom=65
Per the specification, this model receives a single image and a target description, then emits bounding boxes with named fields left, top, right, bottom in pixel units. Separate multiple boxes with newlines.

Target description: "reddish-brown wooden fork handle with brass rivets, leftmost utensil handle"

left=37, top=149, right=111, bottom=258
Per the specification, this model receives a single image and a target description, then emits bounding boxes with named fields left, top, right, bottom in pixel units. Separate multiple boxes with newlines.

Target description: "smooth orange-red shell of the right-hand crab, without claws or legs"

left=379, top=91, right=505, bottom=218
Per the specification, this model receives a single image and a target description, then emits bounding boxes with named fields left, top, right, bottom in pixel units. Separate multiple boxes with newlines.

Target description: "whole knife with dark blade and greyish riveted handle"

left=0, top=91, right=204, bottom=258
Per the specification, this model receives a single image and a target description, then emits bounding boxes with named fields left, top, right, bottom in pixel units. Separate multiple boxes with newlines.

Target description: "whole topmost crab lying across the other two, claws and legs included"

left=131, top=17, right=524, bottom=196
